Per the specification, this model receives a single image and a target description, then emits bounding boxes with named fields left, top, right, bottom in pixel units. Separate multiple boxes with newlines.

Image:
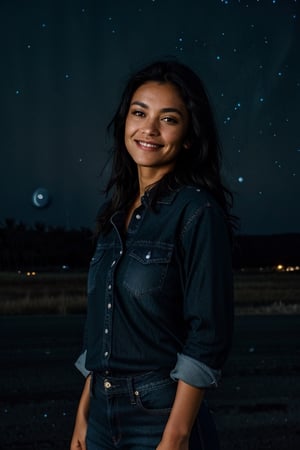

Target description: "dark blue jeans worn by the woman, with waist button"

left=87, top=372, right=219, bottom=450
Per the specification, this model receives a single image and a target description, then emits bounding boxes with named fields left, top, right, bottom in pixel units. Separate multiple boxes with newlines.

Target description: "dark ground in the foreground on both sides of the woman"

left=0, top=315, right=300, bottom=450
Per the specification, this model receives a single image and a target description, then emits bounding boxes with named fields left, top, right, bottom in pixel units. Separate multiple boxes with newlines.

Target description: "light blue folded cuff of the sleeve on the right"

left=170, top=353, right=221, bottom=388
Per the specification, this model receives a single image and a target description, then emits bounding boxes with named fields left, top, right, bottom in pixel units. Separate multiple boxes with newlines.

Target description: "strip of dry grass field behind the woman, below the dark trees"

left=0, top=270, right=300, bottom=315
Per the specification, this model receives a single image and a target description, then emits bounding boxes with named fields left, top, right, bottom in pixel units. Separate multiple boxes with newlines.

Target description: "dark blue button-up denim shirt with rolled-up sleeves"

left=76, top=187, right=233, bottom=388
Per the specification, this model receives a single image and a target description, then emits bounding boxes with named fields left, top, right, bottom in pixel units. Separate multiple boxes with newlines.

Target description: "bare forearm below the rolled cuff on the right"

left=157, top=380, right=205, bottom=450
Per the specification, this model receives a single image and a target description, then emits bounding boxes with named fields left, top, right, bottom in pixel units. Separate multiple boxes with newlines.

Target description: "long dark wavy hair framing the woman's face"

left=97, top=60, right=236, bottom=232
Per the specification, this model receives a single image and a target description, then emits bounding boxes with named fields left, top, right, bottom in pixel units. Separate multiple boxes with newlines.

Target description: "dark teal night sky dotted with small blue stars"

left=0, top=0, right=300, bottom=234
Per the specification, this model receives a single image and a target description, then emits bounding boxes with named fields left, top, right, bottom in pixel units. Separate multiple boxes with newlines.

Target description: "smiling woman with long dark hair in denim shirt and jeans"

left=71, top=61, right=233, bottom=450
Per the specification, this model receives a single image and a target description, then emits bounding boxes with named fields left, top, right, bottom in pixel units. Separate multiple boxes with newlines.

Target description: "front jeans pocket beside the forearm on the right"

left=136, top=378, right=177, bottom=415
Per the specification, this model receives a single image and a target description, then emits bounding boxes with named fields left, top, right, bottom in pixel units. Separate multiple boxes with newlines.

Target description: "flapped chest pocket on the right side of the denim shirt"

left=123, top=243, right=173, bottom=297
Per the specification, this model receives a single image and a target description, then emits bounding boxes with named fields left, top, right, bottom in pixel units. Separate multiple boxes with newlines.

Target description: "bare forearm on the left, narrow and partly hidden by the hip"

left=70, top=375, right=91, bottom=450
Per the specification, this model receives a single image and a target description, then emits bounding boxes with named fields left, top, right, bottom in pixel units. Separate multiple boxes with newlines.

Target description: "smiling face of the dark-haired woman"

left=125, top=81, right=189, bottom=174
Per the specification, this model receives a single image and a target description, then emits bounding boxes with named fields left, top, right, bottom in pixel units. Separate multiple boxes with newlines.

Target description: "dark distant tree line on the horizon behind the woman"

left=0, top=218, right=300, bottom=271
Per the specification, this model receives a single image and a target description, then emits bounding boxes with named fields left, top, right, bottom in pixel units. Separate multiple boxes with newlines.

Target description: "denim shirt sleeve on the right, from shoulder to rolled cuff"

left=171, top=202, right=233, bottom=388
